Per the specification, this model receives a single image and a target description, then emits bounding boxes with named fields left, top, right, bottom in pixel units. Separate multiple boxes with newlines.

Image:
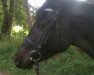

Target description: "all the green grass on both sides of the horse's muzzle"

left=0, top=38, right=94, bottom=75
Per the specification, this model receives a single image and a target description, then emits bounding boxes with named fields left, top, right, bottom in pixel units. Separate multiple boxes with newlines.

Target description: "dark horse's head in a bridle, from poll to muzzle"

left=15, top=0, right=58, bottom=69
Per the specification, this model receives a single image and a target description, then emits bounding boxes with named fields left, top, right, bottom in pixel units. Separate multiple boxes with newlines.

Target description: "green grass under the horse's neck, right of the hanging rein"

left=41, top=47, right=94, bottom=75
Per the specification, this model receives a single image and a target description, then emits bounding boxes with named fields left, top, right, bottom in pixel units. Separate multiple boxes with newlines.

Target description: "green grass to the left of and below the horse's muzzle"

left=0, top=37, right=33, bottom=75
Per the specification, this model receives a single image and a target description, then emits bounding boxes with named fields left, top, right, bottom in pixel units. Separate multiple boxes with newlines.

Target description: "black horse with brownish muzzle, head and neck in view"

left=15, top=0, right=94, bottom=69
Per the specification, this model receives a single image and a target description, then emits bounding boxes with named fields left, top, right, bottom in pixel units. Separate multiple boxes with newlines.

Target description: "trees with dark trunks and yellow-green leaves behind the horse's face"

left=0, top=0, right=36, bottom=36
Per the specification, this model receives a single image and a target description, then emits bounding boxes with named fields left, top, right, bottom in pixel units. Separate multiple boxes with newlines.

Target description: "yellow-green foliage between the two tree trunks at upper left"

left=14, top=0, right=27, bottom=26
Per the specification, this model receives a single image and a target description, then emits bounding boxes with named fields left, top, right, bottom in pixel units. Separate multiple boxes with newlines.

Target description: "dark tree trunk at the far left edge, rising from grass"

left=1, top=0, right=14, bottom=35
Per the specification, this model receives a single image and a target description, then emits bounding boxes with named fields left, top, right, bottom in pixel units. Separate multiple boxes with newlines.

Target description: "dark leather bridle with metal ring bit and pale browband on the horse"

left=26, top=8, right=59, bottom=75
